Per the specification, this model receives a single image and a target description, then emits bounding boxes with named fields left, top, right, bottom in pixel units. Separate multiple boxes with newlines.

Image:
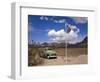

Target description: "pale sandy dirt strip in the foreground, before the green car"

left=42, top=55, right=88, bottom=66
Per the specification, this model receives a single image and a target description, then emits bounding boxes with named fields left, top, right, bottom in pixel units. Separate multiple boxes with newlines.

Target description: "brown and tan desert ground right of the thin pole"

left=67, top=48, right=88, bottom=64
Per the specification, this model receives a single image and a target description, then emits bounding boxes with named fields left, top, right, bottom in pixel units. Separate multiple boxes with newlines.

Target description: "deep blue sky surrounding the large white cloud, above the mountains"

left=28, top=15, right=88, bottom=43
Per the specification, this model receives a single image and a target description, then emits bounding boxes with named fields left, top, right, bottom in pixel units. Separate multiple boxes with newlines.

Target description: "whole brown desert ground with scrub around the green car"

left=28, top=48, right=88, bottom=66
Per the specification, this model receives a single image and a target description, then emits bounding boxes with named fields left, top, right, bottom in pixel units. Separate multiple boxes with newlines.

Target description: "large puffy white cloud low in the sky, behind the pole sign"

left=48, top=26, right=79, bottom=43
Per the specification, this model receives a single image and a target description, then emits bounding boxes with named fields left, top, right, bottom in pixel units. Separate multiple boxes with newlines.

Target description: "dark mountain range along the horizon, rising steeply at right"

left=29, top=36, right=88, bottom=48
